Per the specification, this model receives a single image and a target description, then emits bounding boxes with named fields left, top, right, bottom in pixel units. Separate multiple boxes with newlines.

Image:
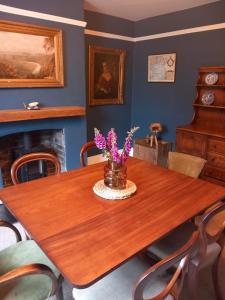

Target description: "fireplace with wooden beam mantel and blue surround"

left=0, top=106, right=87, bottom=187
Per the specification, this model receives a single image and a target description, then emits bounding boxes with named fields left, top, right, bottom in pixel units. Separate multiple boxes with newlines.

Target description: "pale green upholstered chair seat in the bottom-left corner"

left=0, top=240, right=60, bottom=300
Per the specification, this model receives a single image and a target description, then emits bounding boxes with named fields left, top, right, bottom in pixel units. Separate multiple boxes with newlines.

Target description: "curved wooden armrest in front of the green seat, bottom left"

left=0, top=264, right=58, bottom=296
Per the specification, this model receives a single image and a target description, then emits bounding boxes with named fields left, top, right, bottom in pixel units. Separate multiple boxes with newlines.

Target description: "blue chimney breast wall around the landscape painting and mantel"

left=0, top=0, right=86, bottom=169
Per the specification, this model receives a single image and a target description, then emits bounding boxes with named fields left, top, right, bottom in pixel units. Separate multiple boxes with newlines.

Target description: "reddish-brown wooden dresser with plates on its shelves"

left=176, top=67, right=225, bottom=186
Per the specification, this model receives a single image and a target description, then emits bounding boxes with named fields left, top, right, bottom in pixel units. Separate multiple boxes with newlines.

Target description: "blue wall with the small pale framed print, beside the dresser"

left=132, top=1, right=225, bottom=142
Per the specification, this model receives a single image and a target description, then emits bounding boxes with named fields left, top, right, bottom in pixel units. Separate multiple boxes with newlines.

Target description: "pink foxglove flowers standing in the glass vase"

left=94, top=127, right=139, bottom=164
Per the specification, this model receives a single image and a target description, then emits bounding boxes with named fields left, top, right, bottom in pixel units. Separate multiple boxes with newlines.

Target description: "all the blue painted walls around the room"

left=0, top=0, right=225, bottom=162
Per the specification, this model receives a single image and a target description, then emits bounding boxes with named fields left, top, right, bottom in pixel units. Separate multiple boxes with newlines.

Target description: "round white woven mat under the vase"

left=93, top=179, right=137, bottom=200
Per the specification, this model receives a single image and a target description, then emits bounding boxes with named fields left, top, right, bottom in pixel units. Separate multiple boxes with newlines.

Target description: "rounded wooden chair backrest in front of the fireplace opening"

left=11, top=152, right=61, bottom=184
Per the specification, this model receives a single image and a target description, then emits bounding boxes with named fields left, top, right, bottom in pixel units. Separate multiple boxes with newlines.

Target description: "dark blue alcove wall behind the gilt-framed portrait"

left=85, top=12, right=133, bottom=145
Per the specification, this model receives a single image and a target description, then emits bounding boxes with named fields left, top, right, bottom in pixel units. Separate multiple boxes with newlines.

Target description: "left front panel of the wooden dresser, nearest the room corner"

left=176, top=130, right=206, bottom=157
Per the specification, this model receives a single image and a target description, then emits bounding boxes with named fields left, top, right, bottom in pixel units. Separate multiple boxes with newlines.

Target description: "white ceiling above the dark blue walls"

left=84, top=0, right=218, bottom=21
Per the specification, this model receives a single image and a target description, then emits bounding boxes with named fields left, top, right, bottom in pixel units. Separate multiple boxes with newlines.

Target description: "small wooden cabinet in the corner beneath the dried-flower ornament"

left=134, top=138, right=172, bottom=167
